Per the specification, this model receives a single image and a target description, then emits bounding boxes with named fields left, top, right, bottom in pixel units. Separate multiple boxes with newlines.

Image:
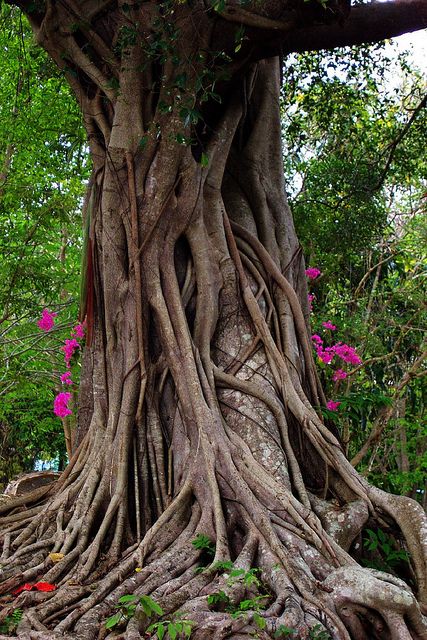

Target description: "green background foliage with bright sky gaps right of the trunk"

left=283, top=45, right=427, bottom=505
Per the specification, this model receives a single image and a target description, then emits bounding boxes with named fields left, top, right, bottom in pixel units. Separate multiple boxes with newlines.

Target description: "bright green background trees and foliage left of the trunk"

left=0, top=4, right=88, bottom=486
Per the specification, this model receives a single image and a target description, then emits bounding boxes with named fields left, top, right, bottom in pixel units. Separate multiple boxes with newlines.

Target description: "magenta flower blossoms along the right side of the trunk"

left=305, top=267, right=362, bottom=411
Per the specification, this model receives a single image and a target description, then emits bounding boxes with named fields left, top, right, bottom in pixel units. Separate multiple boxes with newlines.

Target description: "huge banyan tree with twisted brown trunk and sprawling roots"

left=0, top=0, right=427, bottom=640
